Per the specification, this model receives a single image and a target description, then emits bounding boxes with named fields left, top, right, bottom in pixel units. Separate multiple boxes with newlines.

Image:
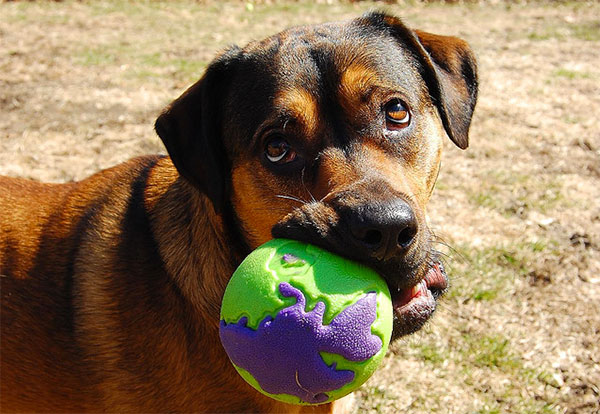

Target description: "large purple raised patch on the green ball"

left=220, top=283, right=382, bottom=404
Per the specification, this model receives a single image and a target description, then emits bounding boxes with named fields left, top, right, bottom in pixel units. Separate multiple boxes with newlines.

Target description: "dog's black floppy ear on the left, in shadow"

left=154, top=47, right=240, bottom=211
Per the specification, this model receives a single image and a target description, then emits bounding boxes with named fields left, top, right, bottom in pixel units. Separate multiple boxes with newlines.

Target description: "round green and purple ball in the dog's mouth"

left=220, top=239, right=393, bottom=404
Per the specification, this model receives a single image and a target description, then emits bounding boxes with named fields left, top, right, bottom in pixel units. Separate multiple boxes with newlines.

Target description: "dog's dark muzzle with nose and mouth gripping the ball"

left=272, top=197, right=448, bottom=338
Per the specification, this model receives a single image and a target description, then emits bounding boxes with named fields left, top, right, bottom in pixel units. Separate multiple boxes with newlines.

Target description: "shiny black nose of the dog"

left=347, top=198, right=418, bottom=260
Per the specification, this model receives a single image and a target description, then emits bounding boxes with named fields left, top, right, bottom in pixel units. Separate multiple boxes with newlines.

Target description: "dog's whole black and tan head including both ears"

left=157, top=14, right=477, bottom=336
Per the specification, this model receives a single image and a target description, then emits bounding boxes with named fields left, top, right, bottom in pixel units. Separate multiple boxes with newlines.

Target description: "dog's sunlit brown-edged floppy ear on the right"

left=366, top=13, right=477, bottom=149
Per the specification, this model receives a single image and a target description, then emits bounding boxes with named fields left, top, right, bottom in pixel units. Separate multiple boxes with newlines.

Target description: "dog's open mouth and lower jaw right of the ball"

left=388, top=262, right=448, bottom=340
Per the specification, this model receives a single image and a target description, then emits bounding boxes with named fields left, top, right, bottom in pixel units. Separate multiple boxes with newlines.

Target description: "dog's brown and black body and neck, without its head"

left=0, top=157, right=340, bottom=412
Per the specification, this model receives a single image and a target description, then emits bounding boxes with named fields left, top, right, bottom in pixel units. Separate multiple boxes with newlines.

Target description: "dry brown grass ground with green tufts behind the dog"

left=0, top=0, right=600, bottom=414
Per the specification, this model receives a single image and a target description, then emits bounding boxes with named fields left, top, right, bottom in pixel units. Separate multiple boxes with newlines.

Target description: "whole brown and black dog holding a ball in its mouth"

left=0, top=13, right=477, bottom=412
